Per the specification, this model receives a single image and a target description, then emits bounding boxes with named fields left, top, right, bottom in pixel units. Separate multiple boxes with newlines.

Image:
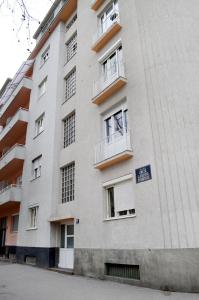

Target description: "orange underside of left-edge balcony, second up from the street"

left=0, top=158, right=24, bottom=181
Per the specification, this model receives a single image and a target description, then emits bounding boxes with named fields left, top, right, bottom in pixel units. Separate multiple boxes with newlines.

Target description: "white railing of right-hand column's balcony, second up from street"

left=93, top=61, right=125, bottom=97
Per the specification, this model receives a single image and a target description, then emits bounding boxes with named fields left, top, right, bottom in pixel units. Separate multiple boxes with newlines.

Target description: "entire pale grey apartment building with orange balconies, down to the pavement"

left=0, top=0, right=199, bottom=291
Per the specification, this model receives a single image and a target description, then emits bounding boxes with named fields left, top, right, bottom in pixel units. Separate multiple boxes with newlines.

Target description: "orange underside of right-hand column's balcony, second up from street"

left=92, top=76, right=127, bottom=105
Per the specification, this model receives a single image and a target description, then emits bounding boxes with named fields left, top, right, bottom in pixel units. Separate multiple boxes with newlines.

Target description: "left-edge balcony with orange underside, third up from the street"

left=0, top=108, right=29, bottom=151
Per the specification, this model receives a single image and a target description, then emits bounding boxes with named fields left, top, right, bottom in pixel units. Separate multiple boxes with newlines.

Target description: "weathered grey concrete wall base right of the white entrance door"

left=74, top=248, right=199, bottom=292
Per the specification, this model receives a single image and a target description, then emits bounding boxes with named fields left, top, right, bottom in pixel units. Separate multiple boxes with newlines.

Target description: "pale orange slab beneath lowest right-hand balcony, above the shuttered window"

left=95, top=150, right=133, bottom=170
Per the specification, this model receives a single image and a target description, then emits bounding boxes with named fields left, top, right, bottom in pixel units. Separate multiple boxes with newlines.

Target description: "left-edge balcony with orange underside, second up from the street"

left=0, top=144, right=25, bottom=180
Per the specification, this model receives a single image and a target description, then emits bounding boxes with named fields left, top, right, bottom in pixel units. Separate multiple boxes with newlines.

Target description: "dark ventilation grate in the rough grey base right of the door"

left=105, top=263, right=140, bottom=280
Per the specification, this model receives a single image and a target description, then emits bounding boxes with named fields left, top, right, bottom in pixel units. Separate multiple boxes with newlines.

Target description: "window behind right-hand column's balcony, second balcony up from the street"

left=102, top=45, right=124, bottom=87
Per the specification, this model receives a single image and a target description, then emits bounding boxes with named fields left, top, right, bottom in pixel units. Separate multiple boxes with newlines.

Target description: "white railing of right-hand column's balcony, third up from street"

left=93, top=9, right=120, bottom=44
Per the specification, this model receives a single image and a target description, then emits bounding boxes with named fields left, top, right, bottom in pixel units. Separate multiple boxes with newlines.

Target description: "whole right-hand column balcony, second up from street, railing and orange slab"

left=92, top=61, right=127, bottom=105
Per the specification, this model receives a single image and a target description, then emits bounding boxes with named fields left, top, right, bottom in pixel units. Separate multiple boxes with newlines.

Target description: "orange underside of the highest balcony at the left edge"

left=0, top=87, right=31, bottom=125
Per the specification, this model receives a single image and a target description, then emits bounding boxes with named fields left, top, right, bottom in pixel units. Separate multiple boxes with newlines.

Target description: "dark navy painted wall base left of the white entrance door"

left=16, top=246, right=59, bottom=268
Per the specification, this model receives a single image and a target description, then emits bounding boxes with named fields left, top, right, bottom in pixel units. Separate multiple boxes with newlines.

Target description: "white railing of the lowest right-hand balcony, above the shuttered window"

left=95, top=128, right=132, bottom=164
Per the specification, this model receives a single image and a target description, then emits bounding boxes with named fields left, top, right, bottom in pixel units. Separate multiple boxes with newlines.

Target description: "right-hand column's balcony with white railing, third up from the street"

left=92, top=10, right=122, bottom=52
